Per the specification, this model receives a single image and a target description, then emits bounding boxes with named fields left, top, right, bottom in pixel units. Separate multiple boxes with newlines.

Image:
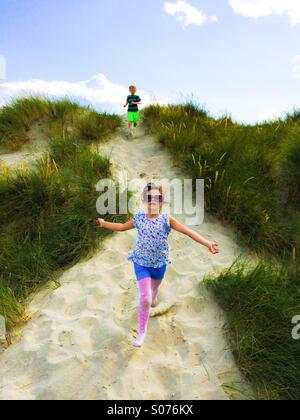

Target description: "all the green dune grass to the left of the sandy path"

left=0, top=98, right=121, bottom=328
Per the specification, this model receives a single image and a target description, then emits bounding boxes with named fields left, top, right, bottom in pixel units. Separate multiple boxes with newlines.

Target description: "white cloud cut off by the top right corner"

left=229, top=0, right=300, bottom=26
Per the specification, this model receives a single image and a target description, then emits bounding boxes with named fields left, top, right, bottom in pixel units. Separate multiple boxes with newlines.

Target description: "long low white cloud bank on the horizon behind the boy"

left=0, top=74, right=168, bottom=113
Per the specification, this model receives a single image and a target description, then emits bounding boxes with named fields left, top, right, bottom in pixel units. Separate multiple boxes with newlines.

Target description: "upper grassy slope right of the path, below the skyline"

left=143, top=104, right=300, bottom=257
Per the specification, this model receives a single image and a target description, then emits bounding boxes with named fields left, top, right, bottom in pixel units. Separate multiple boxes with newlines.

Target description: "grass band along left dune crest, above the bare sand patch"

left=0, top=97, right=121, bottom=151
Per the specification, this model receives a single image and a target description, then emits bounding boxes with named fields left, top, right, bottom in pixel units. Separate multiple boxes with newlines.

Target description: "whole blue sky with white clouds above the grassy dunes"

left=0, top=0, right=300, bottom=122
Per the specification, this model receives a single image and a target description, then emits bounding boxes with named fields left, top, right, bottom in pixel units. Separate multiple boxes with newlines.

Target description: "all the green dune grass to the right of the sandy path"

left=143, top=104, right=300, bottom=399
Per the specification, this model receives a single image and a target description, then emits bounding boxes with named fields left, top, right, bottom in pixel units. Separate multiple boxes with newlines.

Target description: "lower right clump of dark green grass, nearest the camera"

left=206, top=263, right=300, bottom=400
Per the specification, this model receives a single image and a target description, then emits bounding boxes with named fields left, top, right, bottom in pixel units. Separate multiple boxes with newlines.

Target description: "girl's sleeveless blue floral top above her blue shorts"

left=128, top=211, right=171, bottom=268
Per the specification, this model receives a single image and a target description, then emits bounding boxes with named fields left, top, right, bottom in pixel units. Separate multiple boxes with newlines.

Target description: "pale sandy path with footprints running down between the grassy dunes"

left=0, top=124, right=250, bottom=400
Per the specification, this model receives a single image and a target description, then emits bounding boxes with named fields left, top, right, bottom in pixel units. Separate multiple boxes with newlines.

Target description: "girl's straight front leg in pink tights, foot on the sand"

left=134, top=277, right=152, bottom=347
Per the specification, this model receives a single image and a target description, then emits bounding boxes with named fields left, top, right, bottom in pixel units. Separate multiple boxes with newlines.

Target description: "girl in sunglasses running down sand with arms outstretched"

left=97, top=183, right=219, bottom=347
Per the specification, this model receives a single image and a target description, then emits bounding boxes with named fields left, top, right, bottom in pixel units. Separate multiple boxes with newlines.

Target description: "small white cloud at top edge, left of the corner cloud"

left=164, top=0, right=218, bottom=28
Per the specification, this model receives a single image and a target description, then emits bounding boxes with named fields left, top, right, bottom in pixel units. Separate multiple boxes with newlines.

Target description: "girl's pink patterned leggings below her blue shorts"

left=138, top=277, right=162, bottom=335
